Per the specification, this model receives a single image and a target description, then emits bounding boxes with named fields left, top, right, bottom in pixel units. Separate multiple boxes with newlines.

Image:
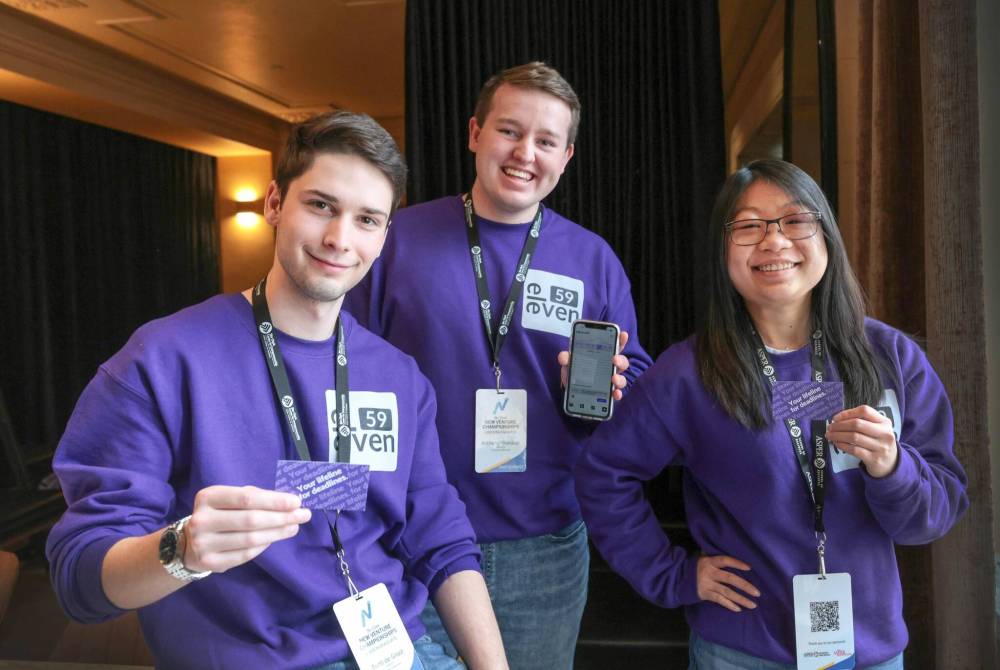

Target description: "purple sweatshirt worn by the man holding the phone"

left=345, top=196, right=652, bottom=542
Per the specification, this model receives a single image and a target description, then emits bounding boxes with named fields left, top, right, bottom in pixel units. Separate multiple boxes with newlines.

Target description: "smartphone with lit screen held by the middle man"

left=563, top=319, right=618, bottom=421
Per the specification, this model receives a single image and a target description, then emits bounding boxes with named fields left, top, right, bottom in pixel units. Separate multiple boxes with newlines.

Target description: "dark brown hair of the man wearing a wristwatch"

left=274, top=111, right=406, bottom=215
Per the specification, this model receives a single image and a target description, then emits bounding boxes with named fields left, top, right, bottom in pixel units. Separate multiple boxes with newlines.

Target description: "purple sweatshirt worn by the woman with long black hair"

left=576, top=319, right=968, bottom=667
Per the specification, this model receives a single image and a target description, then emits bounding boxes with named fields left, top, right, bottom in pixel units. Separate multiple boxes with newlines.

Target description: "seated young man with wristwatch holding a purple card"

left=48, top=112, right=506, bottom=670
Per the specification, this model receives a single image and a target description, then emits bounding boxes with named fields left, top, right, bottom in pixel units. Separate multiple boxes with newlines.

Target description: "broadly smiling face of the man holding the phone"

left=469, top=84, right=573, bottom=223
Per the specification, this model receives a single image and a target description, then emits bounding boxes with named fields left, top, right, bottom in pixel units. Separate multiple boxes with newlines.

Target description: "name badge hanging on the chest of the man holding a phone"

left=475, top=389, right=528, bottom=474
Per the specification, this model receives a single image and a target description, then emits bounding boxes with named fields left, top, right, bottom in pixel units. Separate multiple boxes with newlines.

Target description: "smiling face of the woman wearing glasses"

left=726, top=179, right=827, bottom=313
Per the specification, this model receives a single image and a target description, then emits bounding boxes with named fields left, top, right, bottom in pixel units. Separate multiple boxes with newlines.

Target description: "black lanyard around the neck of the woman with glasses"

left=752, top=329, right=827, bottom=537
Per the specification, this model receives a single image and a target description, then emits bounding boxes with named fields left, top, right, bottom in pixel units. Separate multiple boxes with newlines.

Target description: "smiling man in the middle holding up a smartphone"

left=345, top=62, right=651, bottom=670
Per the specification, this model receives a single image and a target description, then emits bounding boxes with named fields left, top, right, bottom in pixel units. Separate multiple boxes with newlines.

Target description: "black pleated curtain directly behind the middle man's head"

left=406, top=0, right=725, bottom=356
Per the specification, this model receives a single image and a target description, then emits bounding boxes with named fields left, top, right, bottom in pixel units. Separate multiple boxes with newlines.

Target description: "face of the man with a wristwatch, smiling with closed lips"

left=264, top=153, right=393, bottom=303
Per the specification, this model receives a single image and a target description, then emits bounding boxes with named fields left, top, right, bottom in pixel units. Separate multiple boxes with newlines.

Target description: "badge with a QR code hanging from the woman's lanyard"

left=792, top=572, right=856, bottom=670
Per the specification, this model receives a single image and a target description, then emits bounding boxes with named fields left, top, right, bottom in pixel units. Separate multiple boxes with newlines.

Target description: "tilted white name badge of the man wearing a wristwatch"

left=333, top=584, right=414, bottom=670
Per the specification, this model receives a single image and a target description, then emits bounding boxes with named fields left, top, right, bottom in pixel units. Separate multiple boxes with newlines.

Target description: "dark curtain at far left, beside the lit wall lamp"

left=0, top=101, right=219, bottom=472
